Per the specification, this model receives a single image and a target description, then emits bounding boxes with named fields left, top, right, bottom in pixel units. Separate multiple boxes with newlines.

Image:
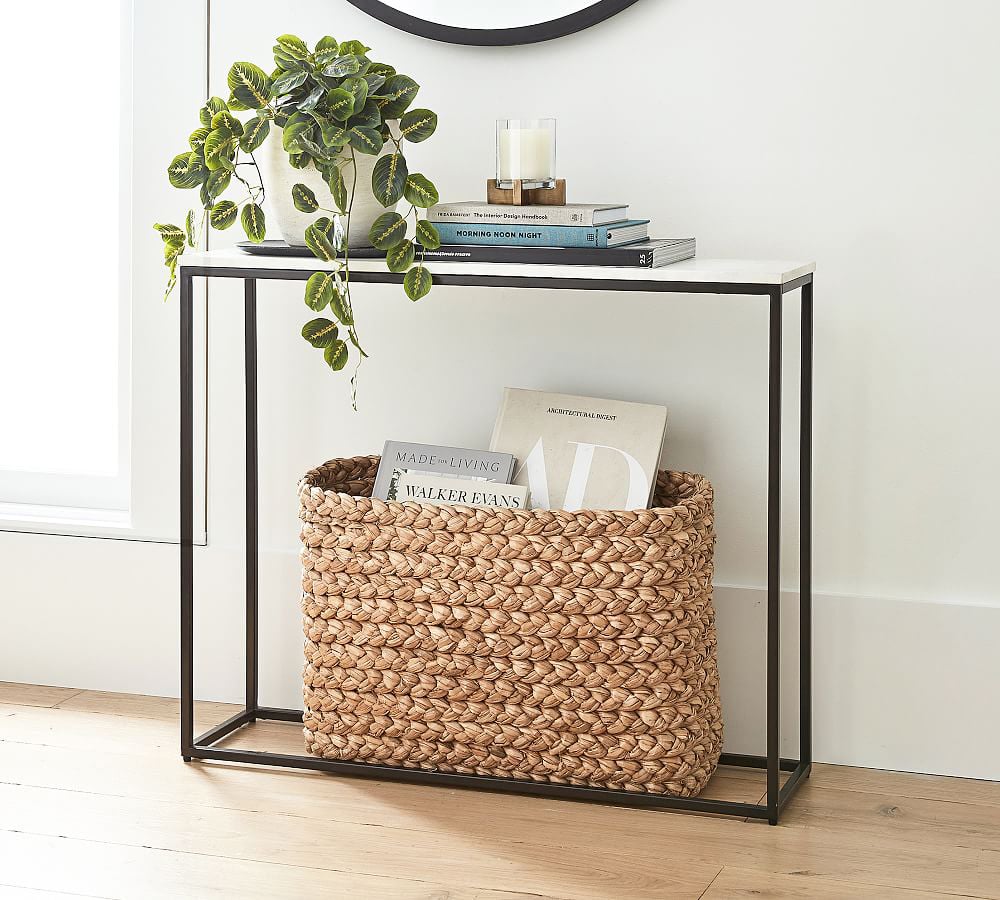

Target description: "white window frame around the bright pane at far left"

left=0, top=0, right=208, bottom=543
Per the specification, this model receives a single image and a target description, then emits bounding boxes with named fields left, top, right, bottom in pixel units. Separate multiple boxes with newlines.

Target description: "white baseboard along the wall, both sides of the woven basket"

left=0, top=535, right=1000, bottom=780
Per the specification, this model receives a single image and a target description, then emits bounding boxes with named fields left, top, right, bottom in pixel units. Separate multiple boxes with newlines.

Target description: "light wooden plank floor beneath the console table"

left=0, top=683, right=1000, bottom=900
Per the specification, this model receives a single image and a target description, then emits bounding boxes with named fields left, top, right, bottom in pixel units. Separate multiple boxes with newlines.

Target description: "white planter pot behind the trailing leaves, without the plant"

left=260, top=130, right=395, bottom=249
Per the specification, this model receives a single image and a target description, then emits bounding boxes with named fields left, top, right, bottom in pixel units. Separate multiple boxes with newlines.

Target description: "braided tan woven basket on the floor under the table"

left=299, top=456, right=722, bottom=796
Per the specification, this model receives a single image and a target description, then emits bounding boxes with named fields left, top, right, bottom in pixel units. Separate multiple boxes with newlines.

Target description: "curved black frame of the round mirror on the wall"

left=347, top=0, right=635, bottom=47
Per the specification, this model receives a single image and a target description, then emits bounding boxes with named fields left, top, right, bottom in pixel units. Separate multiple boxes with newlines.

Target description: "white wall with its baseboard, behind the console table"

left=0, top=0, right=1000, bottom=778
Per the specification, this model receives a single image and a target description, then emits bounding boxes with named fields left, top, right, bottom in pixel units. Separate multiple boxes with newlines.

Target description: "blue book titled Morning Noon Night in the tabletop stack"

left=434, top=219, right=649, bottom=249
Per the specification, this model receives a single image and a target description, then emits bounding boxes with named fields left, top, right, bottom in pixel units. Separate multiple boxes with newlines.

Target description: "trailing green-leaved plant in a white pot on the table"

left=154, top=34, right=441, bottom=384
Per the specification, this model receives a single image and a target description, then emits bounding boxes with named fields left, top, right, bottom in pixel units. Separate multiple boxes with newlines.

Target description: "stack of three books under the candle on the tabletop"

left=424, top=201, right=695, bottom=268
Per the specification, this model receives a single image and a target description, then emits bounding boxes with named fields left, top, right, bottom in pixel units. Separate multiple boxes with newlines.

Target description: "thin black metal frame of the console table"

left=180, top=266, right=813, bottom=825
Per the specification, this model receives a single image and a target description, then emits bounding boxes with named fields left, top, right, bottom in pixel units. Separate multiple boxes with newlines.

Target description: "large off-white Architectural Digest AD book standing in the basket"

left=490, top=388, right=667, bottom=510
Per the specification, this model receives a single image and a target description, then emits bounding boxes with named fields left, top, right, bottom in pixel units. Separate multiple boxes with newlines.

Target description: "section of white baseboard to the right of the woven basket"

left=715, top=585, right=1000, bottom=780
